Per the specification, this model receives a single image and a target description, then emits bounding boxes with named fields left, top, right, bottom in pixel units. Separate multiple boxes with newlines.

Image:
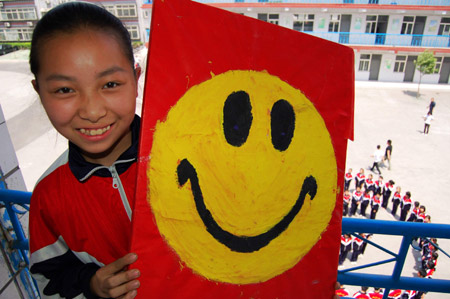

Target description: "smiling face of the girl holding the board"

left=33, top=30, right=140, bottom=166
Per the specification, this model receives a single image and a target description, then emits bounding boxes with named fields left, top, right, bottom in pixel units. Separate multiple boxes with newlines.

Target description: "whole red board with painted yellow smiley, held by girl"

left=131, top=0, right=354, bottom=298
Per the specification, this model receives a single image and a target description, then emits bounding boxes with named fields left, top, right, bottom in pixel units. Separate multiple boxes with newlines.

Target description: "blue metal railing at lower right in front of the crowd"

left=338, top=218, right=450, bottom=298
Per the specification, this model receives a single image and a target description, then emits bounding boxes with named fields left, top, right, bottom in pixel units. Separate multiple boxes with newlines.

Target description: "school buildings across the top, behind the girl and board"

left=0, top=0, right=450, bottom=84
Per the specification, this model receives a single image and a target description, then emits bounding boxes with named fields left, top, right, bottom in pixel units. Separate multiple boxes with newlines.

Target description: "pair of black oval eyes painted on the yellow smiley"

left=223, top=91, right=295, bottom=151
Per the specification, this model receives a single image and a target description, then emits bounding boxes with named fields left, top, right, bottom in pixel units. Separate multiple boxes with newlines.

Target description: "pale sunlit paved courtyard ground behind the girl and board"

left=0, top=51, right=450, bottom=299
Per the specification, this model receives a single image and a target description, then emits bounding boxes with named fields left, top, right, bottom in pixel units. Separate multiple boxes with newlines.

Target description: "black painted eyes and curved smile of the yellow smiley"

left=177, top=91, right=317, bottom=253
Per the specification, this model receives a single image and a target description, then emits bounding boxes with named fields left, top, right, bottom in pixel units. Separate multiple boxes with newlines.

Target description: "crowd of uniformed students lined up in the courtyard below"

left=336, top=168, right=439, bottom=299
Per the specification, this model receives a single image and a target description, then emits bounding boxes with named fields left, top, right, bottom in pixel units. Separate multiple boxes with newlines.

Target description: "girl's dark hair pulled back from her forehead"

left=30, top=2, right=134, bottom=76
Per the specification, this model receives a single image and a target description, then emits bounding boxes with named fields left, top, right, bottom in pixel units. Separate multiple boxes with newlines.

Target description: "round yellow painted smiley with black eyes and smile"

left=148, top=71, right=337, bottom=284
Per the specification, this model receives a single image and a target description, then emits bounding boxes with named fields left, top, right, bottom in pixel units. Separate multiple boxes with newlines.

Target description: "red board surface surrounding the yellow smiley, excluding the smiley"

left=131, top=0, right=354, bottom=298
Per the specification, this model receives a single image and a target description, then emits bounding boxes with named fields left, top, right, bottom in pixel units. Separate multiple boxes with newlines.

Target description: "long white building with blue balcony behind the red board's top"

left=142, top=0, right=450, bottom=84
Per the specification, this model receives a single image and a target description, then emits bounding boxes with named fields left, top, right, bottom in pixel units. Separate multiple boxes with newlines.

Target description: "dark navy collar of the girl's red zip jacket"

left=69, top=115, right=141, bottom=182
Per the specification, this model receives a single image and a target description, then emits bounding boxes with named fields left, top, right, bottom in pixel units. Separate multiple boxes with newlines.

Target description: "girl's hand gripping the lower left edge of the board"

left=90, top=253, right=140, bottom=299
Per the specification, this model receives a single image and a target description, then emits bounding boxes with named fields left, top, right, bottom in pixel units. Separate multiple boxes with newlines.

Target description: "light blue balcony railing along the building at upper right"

left=305, top=32, right=450, bottom=48
